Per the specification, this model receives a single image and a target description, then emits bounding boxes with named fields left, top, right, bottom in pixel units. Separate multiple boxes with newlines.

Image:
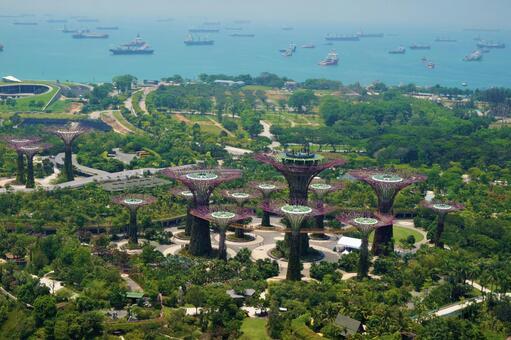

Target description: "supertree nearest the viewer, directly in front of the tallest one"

left=263, top=201, right=323, bottom=281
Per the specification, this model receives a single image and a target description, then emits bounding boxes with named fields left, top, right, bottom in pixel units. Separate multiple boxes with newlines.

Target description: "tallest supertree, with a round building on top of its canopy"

left=254, top=146, right=346, bottom=255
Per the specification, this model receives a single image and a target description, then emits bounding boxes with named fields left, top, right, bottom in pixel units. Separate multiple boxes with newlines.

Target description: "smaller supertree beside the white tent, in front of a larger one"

left=337, top=212, right=392, bottom=279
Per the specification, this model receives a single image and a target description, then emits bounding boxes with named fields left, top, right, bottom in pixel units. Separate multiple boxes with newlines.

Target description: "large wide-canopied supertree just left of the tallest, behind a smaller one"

left=161, top=167, right=241, bottom=256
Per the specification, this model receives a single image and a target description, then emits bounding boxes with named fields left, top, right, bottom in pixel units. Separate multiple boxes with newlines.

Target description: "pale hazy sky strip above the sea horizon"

left=0, top=0, right=511, bottom=28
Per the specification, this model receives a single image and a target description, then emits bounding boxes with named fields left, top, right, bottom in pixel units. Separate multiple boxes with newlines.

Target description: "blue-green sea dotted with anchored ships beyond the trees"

left=0, top=17, right=511, bottom=88
